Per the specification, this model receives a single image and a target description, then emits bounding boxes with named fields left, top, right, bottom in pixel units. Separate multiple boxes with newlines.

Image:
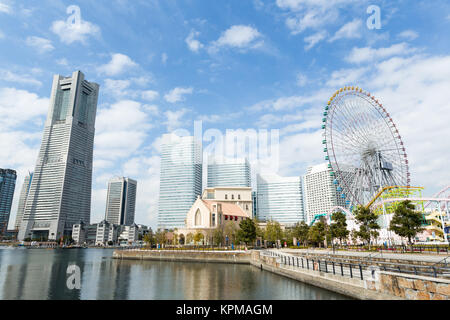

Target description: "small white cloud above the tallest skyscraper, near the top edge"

left=50, top=14, right=100, bottom=44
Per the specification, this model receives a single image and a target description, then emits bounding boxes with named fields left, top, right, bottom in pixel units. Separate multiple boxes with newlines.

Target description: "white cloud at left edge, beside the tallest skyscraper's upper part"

left=0, top=88, right=49, bottom=130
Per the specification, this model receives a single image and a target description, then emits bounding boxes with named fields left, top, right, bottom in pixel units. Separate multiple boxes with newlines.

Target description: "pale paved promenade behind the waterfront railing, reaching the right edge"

left=274, top=249, right=450, bottom=263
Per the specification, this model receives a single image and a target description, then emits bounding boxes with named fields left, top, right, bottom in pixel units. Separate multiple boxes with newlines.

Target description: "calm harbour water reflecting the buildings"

left=0, top=249, right=347, bottom=300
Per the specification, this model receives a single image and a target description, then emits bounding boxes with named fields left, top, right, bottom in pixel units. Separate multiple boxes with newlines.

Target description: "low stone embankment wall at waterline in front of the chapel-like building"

left=113, top=250, right=250, bottom=264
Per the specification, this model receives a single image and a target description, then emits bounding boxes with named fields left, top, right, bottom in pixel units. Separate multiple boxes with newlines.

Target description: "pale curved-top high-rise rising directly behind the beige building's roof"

left=208, top=157, right=252, bottom=188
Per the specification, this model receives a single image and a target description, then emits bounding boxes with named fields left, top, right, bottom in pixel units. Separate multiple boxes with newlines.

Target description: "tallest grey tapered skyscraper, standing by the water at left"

left=18, top=71, right=99, bottom=240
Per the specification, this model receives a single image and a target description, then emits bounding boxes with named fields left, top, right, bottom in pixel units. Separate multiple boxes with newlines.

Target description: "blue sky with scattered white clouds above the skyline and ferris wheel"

left=0, top=0, right=450, bottom=228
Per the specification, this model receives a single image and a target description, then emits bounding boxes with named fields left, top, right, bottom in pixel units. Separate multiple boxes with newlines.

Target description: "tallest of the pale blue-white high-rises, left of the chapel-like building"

left=158, top=135, right=202, bottom=229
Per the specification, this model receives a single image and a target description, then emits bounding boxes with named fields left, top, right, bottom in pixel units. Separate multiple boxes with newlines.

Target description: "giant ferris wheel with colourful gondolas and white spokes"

left=322, top=87, right=410, bottom=208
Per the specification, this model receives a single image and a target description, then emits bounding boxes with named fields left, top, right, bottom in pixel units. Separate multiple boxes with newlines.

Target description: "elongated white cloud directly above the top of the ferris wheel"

left=346, top=42, right=417, bottom=63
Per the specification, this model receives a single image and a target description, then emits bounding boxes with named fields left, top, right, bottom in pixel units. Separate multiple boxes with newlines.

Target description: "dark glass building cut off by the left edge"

left=0, top=169, right=17, bottom=235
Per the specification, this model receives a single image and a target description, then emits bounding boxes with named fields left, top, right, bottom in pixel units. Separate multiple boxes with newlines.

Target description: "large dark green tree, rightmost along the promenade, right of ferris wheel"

left=389, top=200, right=424, bottom=245
